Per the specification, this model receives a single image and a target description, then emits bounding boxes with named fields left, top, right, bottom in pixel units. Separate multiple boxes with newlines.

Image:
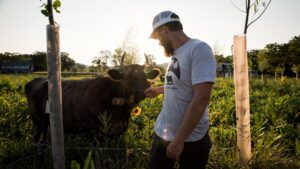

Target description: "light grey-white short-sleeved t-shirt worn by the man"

left=154, top=39, right=216, bottom=142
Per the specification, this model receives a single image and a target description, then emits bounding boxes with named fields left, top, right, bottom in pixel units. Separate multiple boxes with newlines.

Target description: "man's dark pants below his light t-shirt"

left=150, top=134, right=211, bottom=169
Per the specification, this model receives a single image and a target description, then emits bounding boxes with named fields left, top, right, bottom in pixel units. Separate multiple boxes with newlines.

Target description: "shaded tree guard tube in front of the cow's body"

left=47, top=25, right=65, bottom=169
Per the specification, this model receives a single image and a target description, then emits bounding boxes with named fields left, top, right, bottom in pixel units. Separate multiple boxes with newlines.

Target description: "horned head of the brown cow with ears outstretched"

left=108, top=54, right=160, bottom=103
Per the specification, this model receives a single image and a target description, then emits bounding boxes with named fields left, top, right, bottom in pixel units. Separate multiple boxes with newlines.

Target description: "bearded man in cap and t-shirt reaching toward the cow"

left=145, top=11, right=216, bottom=169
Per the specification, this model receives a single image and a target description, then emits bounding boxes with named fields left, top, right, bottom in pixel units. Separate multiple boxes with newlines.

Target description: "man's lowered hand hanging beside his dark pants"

left=167, top=141, right=184, bottom=160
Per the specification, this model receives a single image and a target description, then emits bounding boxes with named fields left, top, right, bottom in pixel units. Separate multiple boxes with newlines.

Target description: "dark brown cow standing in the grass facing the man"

left=25, top=60, right=159, bottom=142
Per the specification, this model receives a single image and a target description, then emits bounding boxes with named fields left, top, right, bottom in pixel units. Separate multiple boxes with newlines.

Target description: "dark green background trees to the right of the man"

left=215, top=35, right=300, bottom=77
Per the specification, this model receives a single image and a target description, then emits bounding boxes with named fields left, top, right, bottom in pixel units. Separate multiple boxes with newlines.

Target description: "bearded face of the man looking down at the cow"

left=157, top=27, right=174, bottom=57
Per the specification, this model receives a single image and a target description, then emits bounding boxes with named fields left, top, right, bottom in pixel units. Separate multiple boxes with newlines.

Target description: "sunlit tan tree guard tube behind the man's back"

left=233, top=34, right=251, bottom=165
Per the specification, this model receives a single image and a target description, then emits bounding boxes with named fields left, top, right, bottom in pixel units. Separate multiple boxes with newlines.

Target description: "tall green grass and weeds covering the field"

left=0, top=75, right=300, bottom=169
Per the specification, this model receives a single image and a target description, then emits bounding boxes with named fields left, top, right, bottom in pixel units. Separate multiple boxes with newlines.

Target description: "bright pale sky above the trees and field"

left=0, top=0, right=300, bottom=65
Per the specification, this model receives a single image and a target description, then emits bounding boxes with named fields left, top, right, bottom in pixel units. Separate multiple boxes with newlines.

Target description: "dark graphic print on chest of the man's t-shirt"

left=166, top=58, right=180, bottom=87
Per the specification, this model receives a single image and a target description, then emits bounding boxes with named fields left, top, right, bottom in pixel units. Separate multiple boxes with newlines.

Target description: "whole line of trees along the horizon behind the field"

left=0, top=35, right=300, bottom=77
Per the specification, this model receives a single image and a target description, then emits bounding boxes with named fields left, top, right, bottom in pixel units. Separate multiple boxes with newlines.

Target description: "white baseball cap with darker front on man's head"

left=149, top=11, right=180, bottom=39
